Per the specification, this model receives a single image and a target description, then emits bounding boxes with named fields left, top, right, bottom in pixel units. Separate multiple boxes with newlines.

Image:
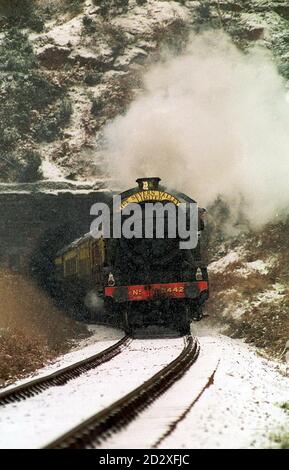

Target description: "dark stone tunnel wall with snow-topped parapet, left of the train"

left=0, top=187, right=111, bottom=322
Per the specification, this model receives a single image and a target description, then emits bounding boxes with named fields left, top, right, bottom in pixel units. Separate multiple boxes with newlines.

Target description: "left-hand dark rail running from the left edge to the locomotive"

left=0, top=335, right=131, bottom=406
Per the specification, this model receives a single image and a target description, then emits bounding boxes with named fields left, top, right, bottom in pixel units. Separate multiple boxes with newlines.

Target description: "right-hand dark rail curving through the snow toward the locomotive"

left=45, top=336, right=200, bottom=449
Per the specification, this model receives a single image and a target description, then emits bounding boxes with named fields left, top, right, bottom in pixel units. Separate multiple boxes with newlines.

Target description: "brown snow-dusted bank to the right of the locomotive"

left=207, top=219, right=289, bottom=359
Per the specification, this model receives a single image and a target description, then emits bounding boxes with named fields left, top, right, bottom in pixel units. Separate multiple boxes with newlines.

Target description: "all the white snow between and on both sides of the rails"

left=0, top=322, right=289, bottom=449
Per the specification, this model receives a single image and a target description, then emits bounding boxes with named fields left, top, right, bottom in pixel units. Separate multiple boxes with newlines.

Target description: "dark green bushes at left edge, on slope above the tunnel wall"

left=0, top=28, right=72, bottom=182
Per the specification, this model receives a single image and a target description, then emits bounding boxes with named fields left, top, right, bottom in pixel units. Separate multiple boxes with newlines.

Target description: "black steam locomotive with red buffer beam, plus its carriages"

left=54, top=177, right=209, bottom=334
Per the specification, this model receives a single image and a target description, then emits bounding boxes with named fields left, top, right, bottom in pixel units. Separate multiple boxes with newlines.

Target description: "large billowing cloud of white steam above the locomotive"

left=105, top=32, right=289, bottom=225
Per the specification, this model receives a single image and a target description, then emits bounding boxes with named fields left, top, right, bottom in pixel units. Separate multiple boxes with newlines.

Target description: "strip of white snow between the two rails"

left=0, top=338, right=184, bottom=449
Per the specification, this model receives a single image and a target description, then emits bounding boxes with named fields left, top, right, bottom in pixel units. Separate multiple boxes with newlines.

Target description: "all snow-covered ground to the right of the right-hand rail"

left=102, top=327, right=289, bottom=449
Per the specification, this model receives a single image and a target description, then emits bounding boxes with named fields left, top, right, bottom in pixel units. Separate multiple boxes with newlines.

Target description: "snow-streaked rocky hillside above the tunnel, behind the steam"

left=0, top=0, right=289, bottom=181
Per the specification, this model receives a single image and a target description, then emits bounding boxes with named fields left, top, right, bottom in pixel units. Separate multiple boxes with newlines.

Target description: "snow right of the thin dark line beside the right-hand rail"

left=162, top=335, right=289, bottom=448
